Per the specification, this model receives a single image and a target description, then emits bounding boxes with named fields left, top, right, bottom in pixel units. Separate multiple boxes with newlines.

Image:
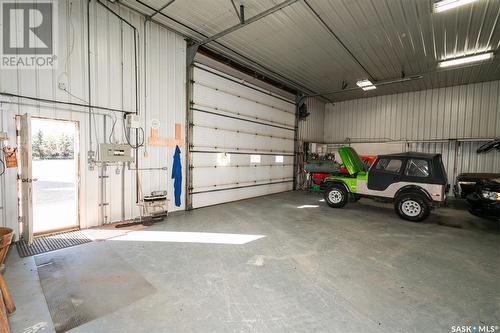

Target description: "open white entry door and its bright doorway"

left=17, top=114, right=79, bottom=244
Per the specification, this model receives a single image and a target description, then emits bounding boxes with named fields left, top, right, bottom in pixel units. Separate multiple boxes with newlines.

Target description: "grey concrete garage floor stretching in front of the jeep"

left=6, top=192, right=500, bottom=332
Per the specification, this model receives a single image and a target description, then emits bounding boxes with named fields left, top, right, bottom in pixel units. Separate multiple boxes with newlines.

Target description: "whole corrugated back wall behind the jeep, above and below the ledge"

left=324, top=81, right=500, bottom=183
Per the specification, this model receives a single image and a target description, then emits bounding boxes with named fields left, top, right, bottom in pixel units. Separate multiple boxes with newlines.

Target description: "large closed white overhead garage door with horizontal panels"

left=188, top=64, right=295, bottom=208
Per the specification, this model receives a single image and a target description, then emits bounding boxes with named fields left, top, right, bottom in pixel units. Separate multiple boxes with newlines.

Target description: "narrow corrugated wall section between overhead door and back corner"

left=298, top=98, right=326, bottom=142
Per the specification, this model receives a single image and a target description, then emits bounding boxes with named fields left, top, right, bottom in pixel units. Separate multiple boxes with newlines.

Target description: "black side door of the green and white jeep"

left=367, top=156, right=404, bottom=191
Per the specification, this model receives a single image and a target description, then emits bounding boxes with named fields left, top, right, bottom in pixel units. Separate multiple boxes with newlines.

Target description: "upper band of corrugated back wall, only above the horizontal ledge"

left=325, top=81, right=500, bottom=142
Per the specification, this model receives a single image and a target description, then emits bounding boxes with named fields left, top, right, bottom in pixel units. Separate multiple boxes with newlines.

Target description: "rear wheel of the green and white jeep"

left=394, top=193, right=431, bottom=222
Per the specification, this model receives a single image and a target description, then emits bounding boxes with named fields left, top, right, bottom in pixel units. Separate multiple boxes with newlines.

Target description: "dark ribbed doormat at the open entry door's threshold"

left=16, top=230, right=92, bottom=258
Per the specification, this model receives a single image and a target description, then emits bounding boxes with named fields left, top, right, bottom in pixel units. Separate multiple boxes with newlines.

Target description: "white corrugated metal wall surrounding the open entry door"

left=0, top=0, right=186, bottom=230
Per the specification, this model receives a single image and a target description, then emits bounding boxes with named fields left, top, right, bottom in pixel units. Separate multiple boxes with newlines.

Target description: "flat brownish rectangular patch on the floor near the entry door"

left=35, top=242, right=156, bottom=333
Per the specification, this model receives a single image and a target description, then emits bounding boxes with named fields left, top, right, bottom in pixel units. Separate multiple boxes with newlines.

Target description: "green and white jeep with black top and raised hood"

left=322, top=147, right=449, bottom=222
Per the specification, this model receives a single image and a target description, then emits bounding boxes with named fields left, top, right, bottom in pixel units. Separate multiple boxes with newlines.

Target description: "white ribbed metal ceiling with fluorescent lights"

left=123, top=0, right=500, bottom=101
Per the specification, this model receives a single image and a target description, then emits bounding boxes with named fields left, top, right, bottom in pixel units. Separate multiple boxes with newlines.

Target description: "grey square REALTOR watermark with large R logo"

left=0, top=0, right=57, bottom=69
